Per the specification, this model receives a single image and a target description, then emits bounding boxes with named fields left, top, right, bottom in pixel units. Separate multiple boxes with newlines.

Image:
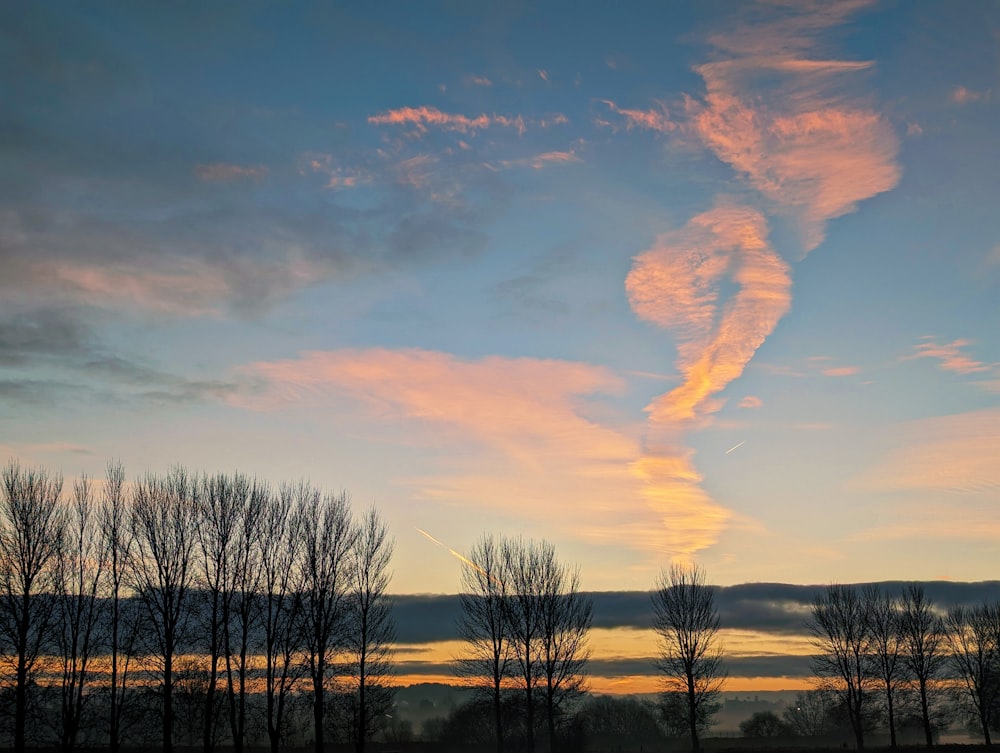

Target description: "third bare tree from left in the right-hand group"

left=900, top=583, right=947, bottom=746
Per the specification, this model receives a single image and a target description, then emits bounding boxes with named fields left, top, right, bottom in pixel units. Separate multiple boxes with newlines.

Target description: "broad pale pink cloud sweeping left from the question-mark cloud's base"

left=231, top=348, right=704, bottom=555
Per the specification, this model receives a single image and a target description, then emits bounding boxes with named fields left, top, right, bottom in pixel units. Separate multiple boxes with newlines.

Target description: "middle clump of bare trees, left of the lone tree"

left=456, top=535, right=593, bottom=753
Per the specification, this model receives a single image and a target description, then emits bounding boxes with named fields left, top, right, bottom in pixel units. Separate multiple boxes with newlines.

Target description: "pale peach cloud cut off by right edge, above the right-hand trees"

left=857, top=408, right=1000, bottom=496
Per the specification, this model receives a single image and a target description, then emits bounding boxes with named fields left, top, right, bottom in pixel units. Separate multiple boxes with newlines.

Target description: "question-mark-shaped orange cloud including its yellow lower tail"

left=625, top=205, right=791, bottom=559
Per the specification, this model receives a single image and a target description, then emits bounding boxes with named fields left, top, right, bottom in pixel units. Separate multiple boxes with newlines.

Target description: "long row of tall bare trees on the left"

left=0, top=462, right=395, bottom=753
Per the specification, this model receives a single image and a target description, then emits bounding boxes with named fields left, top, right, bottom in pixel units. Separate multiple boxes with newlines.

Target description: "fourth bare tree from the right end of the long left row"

left=223, top=475, right=271, bottom=753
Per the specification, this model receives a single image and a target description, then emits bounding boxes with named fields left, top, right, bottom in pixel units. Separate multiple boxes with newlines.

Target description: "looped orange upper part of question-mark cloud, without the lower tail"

left=625, top=206, right=791, bottom=424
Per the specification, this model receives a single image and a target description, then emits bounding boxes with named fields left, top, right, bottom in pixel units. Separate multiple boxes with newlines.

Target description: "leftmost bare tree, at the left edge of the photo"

left=0, top=461, right=64, bottom=753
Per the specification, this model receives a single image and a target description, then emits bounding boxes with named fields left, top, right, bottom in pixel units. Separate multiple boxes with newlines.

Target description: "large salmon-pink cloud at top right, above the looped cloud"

left=685, top=3, right=900, bottom=251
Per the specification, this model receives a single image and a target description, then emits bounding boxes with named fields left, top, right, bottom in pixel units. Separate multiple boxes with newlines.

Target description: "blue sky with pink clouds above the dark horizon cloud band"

left=0, top=0, right=1000, bottom=594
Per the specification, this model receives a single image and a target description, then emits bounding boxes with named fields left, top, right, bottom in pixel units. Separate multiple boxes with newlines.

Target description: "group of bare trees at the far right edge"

left=810, top=584, right=1000, bottom=749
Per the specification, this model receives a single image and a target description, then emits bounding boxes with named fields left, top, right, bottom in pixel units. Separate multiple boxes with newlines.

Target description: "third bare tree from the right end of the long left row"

left=260, top=484, right=306, bottom=753
